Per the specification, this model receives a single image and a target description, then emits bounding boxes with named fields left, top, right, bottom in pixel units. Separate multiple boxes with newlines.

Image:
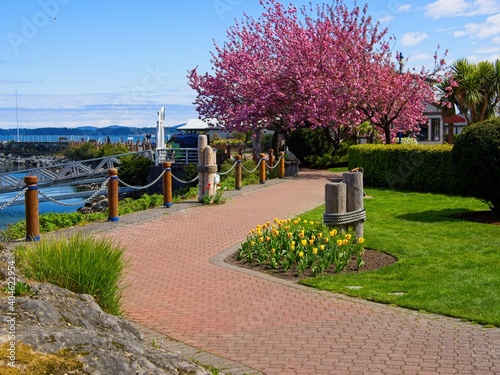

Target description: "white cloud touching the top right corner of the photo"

left=425, top=0, right=500, bottom=20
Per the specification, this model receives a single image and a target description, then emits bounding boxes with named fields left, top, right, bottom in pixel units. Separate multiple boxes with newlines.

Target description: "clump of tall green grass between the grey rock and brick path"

left=15, top=235, right=126, bottom=315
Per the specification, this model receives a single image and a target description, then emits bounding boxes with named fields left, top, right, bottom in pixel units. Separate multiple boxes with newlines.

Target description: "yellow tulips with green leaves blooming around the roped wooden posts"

left=236, top=218, right=364, bottom=276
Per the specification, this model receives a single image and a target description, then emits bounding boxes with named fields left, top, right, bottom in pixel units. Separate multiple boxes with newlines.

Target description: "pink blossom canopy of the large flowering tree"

left=189, top=0, right=448, bottom=146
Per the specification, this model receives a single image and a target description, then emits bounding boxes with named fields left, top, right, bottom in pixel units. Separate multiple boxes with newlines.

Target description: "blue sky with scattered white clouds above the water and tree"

left=0, top=0, right=500, bottom=129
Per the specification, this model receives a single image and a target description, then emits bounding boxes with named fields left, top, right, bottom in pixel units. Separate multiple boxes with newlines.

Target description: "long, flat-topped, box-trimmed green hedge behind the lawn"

left=349, top=144, right=455, bottom=193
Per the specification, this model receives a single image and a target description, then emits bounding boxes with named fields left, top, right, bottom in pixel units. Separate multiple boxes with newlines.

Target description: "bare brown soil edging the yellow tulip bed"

left=226, top=249, right=397, bottom=281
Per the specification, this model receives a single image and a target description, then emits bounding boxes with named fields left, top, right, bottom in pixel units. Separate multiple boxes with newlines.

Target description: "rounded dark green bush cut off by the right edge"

left=451, top=118, right=500, bottom=212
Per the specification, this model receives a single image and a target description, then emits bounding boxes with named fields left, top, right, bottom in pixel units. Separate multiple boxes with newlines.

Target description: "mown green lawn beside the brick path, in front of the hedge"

left=301, top=189, right=500, bottom=326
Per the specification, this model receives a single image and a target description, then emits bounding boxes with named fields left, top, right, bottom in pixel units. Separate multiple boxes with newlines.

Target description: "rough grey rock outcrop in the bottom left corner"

left=0, top=250, right=210, bottom=375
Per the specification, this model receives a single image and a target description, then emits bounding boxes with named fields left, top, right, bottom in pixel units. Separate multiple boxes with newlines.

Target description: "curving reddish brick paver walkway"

left=109, top=171, right=500, bottom=375
